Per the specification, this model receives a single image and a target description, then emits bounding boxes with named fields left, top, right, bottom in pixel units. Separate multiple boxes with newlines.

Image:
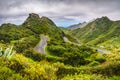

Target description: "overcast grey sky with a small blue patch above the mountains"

left=0, top=0, right=120, bottom=27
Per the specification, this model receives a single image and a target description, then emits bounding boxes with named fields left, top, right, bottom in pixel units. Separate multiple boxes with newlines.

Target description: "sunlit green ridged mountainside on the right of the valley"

left=69, top=17, right=120, bottom=46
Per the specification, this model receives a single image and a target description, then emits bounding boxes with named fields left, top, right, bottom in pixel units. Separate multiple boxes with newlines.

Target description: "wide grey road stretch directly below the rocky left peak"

left=34, top=35, right=48, bottom=54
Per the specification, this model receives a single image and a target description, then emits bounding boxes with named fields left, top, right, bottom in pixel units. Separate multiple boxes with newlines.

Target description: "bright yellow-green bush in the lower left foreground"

left=4, top=54, right=57, bottom=80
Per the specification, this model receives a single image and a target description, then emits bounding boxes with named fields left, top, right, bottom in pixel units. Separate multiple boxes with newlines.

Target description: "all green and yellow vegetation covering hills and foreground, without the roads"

left=0, top=13, right=120, bottom=80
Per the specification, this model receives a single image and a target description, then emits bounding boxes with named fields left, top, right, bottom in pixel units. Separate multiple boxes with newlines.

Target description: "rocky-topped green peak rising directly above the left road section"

left=23, top=13, right=64, bottom=40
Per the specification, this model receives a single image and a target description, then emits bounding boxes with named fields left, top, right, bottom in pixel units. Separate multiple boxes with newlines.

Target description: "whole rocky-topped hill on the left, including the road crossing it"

left=0, top=13, right=94, bottom=63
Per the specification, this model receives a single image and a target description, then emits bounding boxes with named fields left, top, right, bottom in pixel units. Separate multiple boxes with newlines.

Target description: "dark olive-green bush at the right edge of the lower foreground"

left=90, top=62, right=120, bottom=76
